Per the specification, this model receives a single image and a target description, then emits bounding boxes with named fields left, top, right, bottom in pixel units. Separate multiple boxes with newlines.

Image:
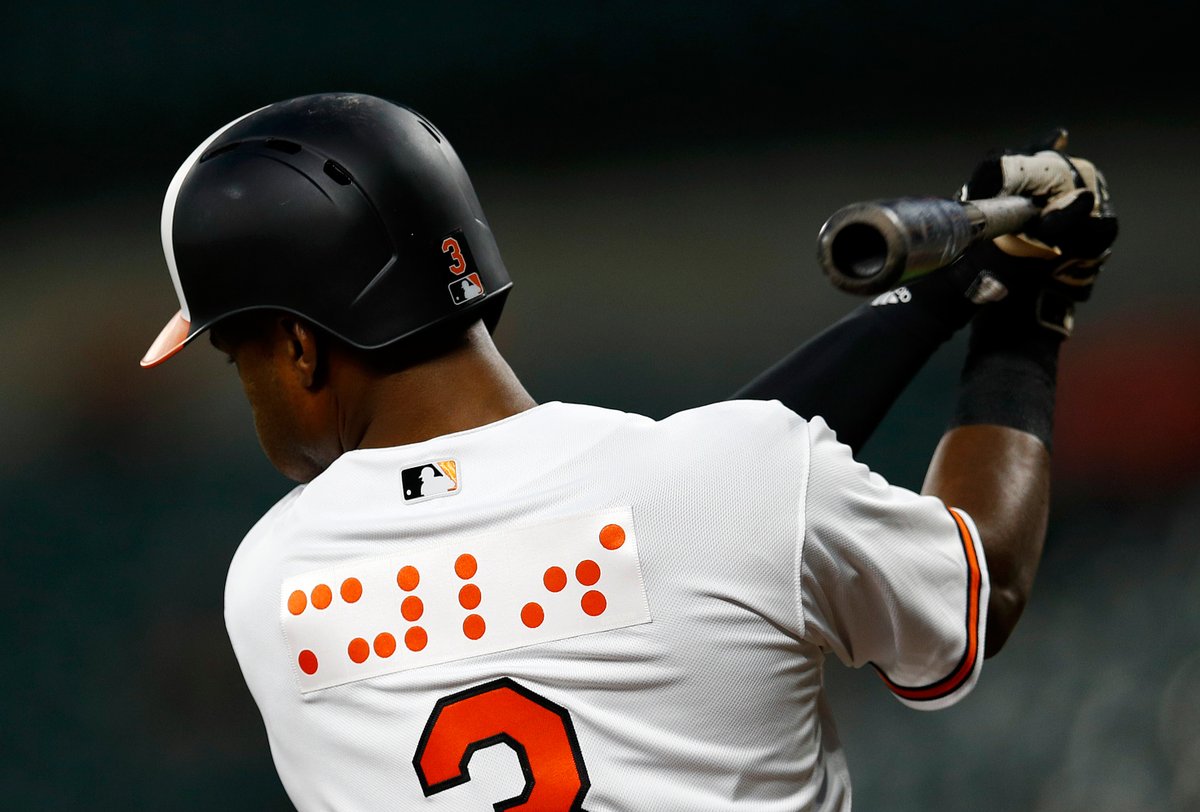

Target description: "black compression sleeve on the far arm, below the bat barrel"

left=733, top=261, right=978, bottom=453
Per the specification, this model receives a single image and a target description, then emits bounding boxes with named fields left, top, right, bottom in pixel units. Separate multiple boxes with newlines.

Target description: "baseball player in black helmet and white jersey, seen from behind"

left=143, top=94, right=1116, bottom=812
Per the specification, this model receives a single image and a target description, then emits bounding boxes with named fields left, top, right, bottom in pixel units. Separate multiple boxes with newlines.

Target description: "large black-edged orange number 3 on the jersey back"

left=413, top=676, right=590, bottom=812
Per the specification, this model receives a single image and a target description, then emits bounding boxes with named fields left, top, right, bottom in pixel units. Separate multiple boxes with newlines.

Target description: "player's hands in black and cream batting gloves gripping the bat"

left=959, top=130, right=1117, bottom=335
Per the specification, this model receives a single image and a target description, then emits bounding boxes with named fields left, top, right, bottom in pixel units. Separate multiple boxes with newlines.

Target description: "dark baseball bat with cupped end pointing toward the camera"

left=817, top=197, right=1040, bottom=295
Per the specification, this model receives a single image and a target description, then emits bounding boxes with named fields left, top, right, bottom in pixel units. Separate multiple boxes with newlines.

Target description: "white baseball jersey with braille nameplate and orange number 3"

left=226, top=401, right=988, bottom=812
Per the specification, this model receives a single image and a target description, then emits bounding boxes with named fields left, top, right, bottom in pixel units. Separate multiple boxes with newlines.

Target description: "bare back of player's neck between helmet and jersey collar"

left=343, top=325, right=536, bottom=450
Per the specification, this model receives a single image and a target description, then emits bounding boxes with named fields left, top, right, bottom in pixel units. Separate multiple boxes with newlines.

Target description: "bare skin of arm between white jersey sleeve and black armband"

left=922, top=425, right=1050, bottom=657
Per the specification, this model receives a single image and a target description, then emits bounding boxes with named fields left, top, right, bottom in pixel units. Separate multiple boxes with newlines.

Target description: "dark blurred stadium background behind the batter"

left=0, top=0, right=1200, bottom=812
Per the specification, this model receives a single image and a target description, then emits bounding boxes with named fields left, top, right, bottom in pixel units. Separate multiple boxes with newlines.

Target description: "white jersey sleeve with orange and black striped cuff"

left=798, top=417, right=989, bottom=710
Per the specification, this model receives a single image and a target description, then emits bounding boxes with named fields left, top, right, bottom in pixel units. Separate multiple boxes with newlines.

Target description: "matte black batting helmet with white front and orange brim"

left=142, top=94, right=512, bottom=367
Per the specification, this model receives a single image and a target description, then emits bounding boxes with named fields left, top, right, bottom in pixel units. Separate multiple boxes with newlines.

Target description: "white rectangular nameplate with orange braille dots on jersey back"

left=280, top=507, right=650, bottom=693
